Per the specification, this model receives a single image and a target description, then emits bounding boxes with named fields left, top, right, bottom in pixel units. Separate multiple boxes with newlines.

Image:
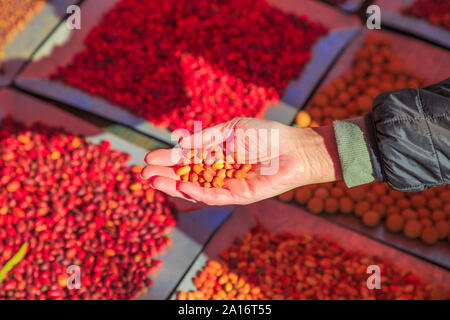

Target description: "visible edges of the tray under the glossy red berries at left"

left=0, top=89, right=233, bottom=299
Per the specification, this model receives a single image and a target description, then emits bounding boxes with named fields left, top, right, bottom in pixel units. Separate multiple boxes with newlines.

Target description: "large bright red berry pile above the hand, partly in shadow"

left=52, top=0, right=327, bottom=130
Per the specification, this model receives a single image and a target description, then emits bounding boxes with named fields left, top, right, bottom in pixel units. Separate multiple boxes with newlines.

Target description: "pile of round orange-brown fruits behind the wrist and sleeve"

left=279, top=34, right=450, bottom=244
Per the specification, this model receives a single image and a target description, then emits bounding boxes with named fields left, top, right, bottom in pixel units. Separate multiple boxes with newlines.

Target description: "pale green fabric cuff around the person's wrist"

left=333, top=118, right=379, bottom=188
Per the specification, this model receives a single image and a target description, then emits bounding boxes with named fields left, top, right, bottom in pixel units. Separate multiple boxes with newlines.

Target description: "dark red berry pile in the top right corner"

left=403, top=0, right=450, bottom=29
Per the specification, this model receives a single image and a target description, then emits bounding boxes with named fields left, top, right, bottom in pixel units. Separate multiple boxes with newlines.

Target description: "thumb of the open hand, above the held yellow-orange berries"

left=179, top=119, right=238, bottom=149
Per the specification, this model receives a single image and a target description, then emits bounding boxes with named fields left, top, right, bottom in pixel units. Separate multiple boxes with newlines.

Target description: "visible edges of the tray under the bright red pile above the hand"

left=15, top=0, right=361, bottom=144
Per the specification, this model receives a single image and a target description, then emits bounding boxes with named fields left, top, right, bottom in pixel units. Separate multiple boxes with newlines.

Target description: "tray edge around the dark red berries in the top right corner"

left=375, top=0, right=450, bottom=49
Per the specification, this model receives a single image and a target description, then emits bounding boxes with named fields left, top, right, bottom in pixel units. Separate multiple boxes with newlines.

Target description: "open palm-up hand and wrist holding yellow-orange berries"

left=142, top=118, right=341, bottom=205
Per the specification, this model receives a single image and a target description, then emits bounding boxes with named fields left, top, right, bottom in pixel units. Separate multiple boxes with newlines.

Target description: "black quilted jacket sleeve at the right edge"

left=365, top=78, right=450, bottom=191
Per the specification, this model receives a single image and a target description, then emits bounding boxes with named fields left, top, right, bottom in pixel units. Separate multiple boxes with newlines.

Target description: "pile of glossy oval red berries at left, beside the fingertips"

left=0, top=119, right=176, bottom=299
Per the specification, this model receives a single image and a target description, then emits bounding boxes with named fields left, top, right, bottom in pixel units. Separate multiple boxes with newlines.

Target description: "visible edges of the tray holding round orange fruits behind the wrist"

left=296, top=30, right=450, bottom=268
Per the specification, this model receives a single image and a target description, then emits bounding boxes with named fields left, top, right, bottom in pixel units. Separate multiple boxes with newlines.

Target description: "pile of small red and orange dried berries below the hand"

left=177, top=226, right=449, bottom=300
